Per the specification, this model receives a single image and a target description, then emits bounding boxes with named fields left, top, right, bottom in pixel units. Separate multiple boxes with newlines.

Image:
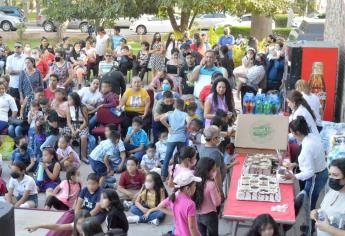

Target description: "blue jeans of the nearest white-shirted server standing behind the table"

left=303, top=168, right=328, bottom=235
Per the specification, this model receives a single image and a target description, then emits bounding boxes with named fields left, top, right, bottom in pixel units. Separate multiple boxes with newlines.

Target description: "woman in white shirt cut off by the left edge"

left=0, top=82, right=18, bottom=134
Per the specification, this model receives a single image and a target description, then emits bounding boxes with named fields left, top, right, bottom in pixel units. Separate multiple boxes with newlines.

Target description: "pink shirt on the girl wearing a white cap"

left=163, top=192, right=201, bottom=236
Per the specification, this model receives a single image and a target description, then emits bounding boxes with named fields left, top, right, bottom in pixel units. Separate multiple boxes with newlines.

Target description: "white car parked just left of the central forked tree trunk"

left=129, top=16, right=180, bottom=35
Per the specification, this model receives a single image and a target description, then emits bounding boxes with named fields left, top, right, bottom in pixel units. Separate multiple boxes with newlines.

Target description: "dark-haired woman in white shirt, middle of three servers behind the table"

left=286, top=90, right=320, bottom=136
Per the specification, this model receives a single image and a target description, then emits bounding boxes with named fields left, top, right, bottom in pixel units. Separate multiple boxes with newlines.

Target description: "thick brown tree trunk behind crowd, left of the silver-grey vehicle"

left=250, top=14, right=272, bottom=41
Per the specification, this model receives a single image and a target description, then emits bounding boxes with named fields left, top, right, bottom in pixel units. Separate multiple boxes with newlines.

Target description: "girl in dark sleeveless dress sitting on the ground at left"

left=36, top=148, right=61, bottom=196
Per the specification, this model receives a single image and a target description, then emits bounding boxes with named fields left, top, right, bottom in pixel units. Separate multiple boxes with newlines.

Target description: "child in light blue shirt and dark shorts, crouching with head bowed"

left=89, top=129, right=126, bottom=186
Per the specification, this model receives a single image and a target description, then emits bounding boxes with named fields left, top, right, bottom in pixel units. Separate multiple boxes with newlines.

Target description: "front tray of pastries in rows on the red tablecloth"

left=236, top=174, right=281, bottom=202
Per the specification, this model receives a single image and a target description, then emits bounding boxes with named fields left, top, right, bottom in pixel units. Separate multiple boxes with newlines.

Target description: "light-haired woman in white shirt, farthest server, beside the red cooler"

left=295, top=80, right=322, bottom=132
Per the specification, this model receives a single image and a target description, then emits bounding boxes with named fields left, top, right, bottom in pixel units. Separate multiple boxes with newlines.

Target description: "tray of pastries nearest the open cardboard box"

left=243, top=154, right=278, bottom=175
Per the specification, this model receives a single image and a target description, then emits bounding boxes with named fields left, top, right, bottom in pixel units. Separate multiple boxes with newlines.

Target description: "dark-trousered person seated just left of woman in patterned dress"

left=133, top=41, right=150, bottom=80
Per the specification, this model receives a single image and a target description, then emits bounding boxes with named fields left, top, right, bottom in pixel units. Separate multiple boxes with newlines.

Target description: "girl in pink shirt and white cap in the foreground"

left=157, top=172, right=201, bottom=236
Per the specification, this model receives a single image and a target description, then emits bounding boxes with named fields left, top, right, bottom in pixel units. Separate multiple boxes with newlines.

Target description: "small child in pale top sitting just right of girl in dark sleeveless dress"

left=56, top=135, right=80, bottom=170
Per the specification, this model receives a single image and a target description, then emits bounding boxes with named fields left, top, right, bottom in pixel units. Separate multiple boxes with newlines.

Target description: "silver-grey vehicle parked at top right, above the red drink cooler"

left=288, top=19, right=325, bottom=41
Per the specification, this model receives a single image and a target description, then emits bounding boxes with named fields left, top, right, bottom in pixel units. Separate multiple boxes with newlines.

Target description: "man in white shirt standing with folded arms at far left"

left=6, top=42, right=26, bottom=105
